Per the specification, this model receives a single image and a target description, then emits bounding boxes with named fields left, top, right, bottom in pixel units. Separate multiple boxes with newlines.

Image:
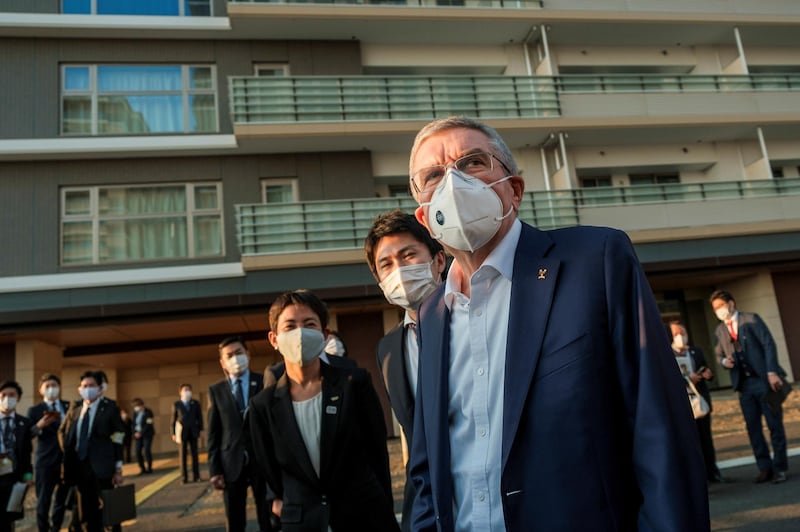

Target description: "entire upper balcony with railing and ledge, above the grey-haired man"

left=229, top=73, right=800, bottom=153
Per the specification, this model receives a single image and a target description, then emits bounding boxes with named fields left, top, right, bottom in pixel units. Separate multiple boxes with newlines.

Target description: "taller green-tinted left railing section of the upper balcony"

left=229, top=76, right=560, bottom=124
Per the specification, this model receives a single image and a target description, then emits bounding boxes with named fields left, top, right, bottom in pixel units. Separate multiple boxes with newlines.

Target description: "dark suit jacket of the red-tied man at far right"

left=715, top=312, right=786, bottom=390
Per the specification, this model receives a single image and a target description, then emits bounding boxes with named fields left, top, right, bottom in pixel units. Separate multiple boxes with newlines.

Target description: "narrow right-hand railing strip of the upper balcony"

left=555, top=73, right=800, bottom=93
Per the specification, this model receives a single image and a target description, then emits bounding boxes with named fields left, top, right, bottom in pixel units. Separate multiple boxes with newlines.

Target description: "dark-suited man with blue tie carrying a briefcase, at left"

left=59, top=371, right=123, bottom=532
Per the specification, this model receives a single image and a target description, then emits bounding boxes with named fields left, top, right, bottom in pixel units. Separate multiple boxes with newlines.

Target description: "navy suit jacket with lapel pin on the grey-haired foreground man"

left=411, top=224, right=709, bottom=532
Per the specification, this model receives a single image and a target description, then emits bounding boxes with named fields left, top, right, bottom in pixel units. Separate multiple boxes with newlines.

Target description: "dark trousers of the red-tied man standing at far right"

left=739, top=376, right=789, bottom=471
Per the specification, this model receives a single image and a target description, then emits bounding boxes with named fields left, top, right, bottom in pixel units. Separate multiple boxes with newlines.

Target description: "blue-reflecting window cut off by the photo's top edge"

left=61, top=0, right=211, bottom=17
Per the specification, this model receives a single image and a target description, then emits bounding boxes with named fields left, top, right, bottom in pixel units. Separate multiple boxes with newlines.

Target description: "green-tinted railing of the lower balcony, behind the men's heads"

left=236, top=178, right=800, bottom=256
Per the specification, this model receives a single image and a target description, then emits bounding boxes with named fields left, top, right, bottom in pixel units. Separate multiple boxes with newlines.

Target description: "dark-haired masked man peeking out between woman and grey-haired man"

left=364, top=209, right=446, bottom=531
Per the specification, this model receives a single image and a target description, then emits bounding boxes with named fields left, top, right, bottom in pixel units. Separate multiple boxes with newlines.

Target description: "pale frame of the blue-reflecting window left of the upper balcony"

left=58, top=63, right=220, bottom=137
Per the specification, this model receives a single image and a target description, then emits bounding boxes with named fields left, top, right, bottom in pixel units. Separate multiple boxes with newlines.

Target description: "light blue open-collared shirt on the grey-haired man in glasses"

left=444, top=220, right=522, bottom=532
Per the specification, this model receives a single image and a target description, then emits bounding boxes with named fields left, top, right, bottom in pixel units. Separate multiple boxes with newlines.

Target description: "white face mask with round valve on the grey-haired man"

left=421, top=168, right=514, bottom=252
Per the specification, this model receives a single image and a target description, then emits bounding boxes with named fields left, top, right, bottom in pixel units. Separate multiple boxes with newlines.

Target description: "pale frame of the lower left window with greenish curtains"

left=59, top=181, right=226, bottom=268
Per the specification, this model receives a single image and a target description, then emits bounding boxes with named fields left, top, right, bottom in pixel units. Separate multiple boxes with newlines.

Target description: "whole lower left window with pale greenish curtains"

left=61, top=183, right=224, bottom=266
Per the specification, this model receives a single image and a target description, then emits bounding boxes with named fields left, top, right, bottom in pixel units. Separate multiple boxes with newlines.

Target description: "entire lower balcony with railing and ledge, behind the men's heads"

left=236, top=178, right=800, bottom=270
